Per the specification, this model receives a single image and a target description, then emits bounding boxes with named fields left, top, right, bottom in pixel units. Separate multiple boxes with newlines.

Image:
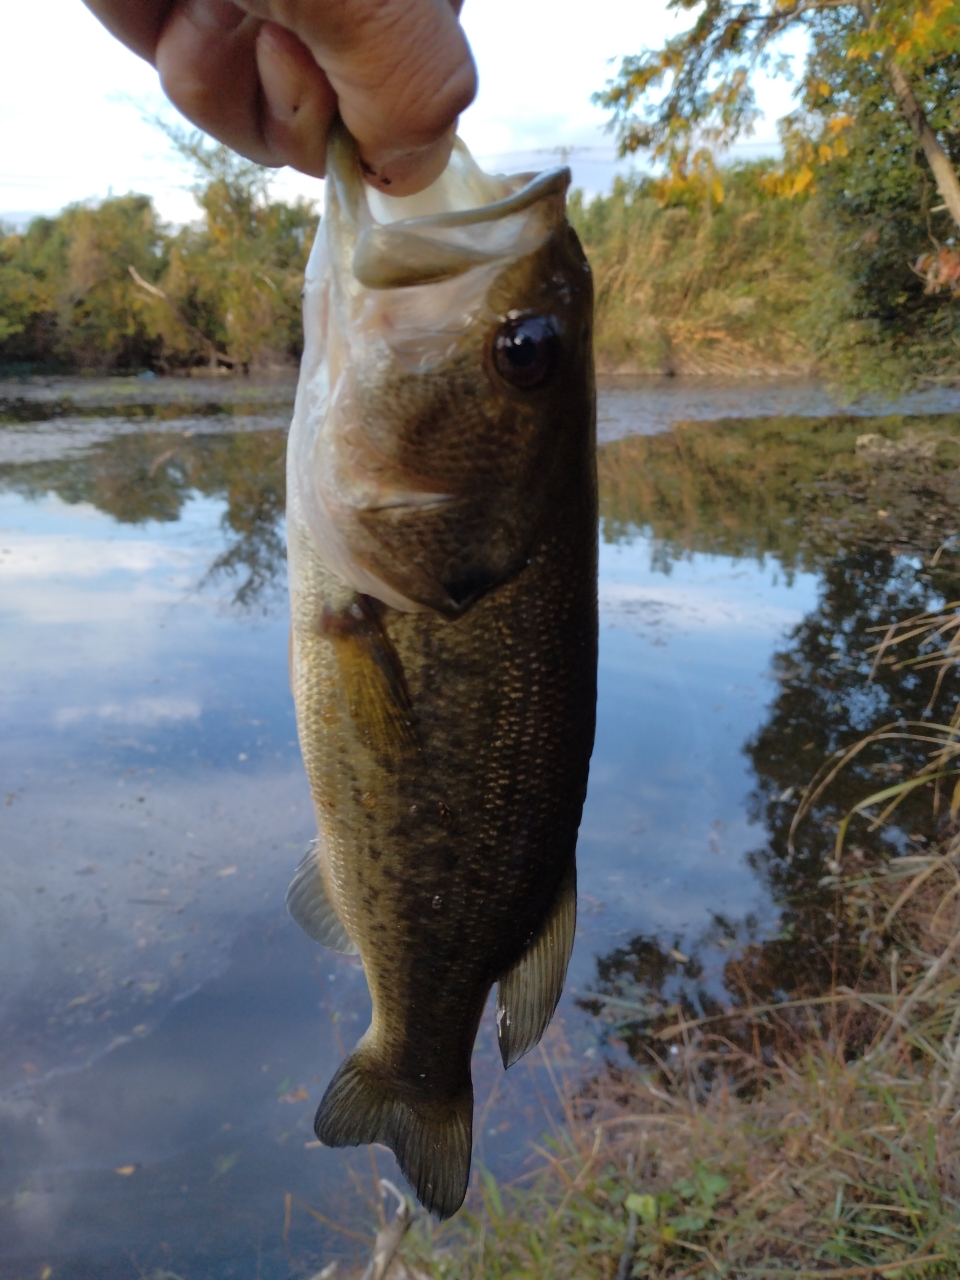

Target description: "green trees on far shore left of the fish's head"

left=0, top=131, right=317, bottom=372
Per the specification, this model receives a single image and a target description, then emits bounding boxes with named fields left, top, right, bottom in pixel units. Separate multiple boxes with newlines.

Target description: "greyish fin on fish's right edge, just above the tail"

left=497, top=858, right=577, bottom=1066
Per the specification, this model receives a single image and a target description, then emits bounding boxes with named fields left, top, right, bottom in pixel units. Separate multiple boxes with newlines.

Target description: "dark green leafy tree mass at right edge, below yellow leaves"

left=808, top=42, right=960, bottom=394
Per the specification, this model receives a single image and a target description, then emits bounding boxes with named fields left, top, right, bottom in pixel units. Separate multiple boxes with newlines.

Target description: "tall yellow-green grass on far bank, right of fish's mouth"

left=571, top=168, right=817, bottom=376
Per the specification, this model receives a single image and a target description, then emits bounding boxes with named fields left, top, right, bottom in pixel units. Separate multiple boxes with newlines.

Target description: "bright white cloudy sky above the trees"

left=0, top=0, right=808, bottom=223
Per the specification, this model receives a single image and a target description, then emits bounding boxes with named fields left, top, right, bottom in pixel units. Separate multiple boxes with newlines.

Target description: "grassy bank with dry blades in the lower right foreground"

left=386, top=840, right=960, bottom=1280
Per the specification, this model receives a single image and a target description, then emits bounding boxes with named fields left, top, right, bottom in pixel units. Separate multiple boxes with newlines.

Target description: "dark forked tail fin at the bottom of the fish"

left=314, top=1043, right=474, bottom=1219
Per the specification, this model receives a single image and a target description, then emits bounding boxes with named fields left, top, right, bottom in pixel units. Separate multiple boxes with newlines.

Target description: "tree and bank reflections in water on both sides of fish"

left=0, top=416, right=960, bottom=1057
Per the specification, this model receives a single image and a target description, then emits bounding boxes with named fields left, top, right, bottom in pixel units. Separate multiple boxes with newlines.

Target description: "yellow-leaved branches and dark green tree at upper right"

left=596, top=0, right=960, bottom=393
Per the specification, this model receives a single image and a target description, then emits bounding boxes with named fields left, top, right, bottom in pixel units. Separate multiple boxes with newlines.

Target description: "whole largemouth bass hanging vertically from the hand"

left=287, top=127, right=598, bottom=1219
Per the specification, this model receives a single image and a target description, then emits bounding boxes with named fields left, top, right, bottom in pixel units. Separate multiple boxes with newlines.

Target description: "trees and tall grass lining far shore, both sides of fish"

left=0, top=0, right=960, bottom=393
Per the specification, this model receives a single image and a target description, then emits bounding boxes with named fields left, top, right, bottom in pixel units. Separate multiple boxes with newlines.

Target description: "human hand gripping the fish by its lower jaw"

left=84, top=0, right=476, bottom=196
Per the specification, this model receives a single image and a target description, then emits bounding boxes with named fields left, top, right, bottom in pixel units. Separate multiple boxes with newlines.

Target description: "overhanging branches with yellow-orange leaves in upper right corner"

left=596, top=0, right=960, bottom=228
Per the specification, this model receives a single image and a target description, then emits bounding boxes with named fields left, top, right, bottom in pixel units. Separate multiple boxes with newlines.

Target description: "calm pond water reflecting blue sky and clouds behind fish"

left=0, top=380, right=960, bottom=1280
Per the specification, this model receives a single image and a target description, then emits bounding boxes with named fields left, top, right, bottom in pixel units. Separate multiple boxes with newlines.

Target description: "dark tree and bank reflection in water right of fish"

left=581, top=417, right=960, bottom=1062
